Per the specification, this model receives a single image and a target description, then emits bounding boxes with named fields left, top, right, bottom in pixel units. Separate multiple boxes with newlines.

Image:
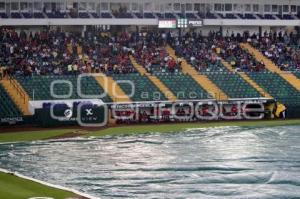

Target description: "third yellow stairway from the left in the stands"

left=130, top=55, right=177, bottom=101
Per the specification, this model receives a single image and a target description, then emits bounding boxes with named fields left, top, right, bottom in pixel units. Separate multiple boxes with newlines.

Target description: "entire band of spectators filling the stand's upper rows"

left=0, top=28, right=300, bottom=78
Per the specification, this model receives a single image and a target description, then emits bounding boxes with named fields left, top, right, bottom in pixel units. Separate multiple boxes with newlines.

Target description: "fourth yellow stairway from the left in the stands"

left=166, top=46, right=228, bottom=100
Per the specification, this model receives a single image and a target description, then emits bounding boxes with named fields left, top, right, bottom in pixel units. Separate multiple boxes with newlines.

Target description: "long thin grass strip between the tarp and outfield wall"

left=0, top=119, right=300, bottom=143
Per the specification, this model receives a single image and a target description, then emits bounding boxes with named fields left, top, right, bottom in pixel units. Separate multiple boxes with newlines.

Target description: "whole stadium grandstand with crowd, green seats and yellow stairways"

left=0, top=0, right=300, bottom=126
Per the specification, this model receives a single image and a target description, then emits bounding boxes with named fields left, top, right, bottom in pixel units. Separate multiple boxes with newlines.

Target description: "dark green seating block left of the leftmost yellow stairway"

left=0, top=84, right=22, bottom=118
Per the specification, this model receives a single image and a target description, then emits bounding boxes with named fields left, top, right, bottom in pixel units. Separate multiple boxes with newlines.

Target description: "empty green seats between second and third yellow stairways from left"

left=113, top=73, right=167, bottom=101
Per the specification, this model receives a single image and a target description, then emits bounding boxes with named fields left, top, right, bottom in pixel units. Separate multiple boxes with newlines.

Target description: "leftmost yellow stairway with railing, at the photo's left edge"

left=0, top=79, right=31, bottom=115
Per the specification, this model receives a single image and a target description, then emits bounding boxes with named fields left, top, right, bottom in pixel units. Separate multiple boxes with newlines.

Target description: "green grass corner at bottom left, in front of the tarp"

left=0, top=172, right=78, bottom=199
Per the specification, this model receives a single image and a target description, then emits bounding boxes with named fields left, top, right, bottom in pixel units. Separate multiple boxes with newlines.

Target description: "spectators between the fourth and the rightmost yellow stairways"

left=172, top=32, right=264, bottom=72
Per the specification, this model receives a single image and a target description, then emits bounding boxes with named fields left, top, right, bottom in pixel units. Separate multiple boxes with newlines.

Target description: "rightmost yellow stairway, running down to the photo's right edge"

left=240, top=43, right=300, bottom=91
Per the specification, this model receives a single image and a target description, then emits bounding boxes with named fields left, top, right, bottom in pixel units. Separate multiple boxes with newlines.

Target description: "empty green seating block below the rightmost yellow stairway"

left=248, top=72, right=300, bottom=106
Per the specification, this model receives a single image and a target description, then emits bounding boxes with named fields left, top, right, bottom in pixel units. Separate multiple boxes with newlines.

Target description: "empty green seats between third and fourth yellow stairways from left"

left=156, top=73, right=212, bottom=100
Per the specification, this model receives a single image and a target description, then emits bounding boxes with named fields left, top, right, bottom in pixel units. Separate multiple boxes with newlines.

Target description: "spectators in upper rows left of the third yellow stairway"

left=0, top=28, right=135, bottom=76
